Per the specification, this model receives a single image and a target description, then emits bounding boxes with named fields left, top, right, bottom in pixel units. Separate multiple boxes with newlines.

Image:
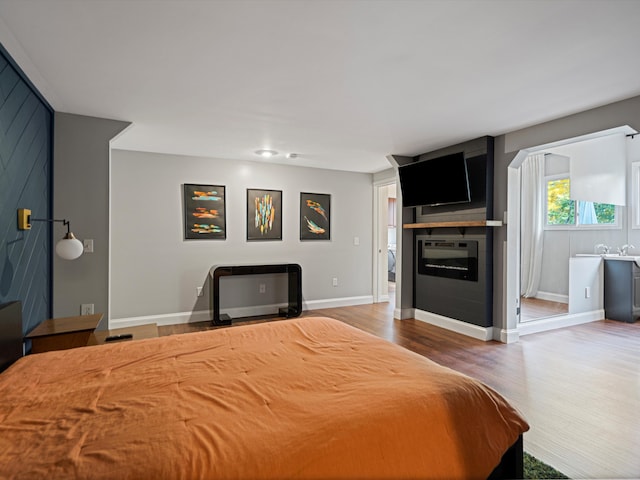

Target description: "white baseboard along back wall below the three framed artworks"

left=109, top=295, right=373, bottom=329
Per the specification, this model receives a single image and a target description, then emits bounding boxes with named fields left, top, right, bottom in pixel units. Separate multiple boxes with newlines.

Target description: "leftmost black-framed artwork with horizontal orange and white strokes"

left=183, top=183, right=227, bottom=240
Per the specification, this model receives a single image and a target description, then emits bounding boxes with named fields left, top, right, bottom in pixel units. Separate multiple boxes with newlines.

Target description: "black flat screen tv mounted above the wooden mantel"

left=399, top=152, right=471, bottom=207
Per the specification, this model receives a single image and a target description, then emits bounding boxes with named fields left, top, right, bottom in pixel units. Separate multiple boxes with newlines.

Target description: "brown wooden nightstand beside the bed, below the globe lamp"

left=25, top=313, right=102, bottom=353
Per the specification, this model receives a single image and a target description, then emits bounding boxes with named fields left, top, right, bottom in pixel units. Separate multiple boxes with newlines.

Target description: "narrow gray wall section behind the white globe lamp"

left=53, top=112, right=129, bottom=323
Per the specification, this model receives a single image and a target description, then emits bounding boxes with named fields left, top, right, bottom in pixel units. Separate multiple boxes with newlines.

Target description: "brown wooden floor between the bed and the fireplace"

left=158, top=303, right=640, bottom=479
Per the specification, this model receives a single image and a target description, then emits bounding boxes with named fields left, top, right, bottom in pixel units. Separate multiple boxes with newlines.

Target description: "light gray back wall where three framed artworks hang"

left=111, top=150, right=373, bottom=321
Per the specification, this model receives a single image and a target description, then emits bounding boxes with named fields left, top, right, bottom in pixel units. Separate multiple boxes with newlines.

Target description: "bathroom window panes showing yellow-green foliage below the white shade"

left=546, top=176, right=618, bottom=229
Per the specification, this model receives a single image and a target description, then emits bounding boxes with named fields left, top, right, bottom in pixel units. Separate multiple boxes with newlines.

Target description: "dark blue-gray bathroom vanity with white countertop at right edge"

left=604, top=255, right=640, bottom=323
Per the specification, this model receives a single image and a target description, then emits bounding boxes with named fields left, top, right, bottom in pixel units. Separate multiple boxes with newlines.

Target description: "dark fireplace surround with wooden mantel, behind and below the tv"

left=403, top=136, right=500, bottom=329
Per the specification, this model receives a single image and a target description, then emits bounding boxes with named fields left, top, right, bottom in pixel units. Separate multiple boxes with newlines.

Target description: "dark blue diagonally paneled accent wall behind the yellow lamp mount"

left=0, top=48, right=53, bottom=333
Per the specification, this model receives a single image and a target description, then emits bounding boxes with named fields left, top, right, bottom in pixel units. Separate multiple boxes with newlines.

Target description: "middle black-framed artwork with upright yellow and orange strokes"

left=247, top=188, right=282, bottom=241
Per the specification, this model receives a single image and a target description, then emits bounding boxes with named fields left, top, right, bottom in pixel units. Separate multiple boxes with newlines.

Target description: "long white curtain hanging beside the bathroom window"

left=520, top=153, right=546, bottom=297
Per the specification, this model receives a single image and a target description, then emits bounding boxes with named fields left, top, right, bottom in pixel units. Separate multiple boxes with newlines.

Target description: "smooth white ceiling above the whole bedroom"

left=0, top=0, right=640, bottom=172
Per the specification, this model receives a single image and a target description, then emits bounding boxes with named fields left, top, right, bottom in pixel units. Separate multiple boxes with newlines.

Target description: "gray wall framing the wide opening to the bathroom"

left=494, top=96, right=640, bottom=329
